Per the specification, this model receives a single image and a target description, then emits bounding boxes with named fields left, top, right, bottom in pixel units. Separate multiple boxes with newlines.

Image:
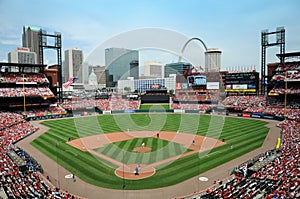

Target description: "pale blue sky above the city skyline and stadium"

left=0, top=0, right=300, bottom=71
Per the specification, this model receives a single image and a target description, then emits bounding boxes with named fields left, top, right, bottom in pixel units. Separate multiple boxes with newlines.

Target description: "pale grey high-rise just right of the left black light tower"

left=64, top=48, right=84, bottom=84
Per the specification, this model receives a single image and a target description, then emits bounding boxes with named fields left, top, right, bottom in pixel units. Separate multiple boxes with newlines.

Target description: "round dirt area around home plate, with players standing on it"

left=115, top=164, right=155, bottom=180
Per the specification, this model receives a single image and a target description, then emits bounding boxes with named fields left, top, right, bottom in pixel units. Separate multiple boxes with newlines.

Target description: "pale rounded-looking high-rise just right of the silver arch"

left=205, top=48, right=222, bottom=72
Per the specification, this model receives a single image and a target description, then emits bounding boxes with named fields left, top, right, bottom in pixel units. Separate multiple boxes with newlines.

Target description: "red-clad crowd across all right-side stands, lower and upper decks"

left=182, top=62, right=300, bottom=199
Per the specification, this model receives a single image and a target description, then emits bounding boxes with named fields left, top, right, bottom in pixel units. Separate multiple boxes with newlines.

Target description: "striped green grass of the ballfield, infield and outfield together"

left=31, top=114, right=269, bottom=190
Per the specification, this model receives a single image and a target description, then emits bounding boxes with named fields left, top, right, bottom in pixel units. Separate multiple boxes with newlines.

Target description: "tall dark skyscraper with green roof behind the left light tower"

left=22, top=26, right=42, bottom=64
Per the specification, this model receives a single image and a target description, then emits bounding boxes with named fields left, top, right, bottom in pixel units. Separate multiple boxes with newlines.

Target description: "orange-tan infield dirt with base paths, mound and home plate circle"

left=67, top=131, right=225, bottom=180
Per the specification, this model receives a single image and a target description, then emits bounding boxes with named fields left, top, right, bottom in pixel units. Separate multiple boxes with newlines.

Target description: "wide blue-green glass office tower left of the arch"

left=105, top=48, right=139, bottom=87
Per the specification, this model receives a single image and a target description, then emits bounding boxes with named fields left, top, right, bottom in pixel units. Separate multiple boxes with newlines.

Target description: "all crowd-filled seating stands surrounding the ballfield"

left=0, top=63, right=300, bottom=198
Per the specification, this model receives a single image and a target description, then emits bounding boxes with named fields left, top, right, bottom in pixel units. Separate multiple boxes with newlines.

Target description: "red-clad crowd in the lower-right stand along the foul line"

left=186, top=117, right=300, bottom=199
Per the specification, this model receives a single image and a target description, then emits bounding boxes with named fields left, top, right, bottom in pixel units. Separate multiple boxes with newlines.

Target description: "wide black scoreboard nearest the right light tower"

left=225, top=72, right=259, bottom=93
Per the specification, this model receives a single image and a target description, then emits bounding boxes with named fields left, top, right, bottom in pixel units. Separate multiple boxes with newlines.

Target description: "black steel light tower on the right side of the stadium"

left=260, top=27, right=285, bottom=95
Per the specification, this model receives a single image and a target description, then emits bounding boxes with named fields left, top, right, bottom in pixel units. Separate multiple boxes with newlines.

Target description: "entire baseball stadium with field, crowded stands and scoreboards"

left=0, top=27, right=300, bottom=199
